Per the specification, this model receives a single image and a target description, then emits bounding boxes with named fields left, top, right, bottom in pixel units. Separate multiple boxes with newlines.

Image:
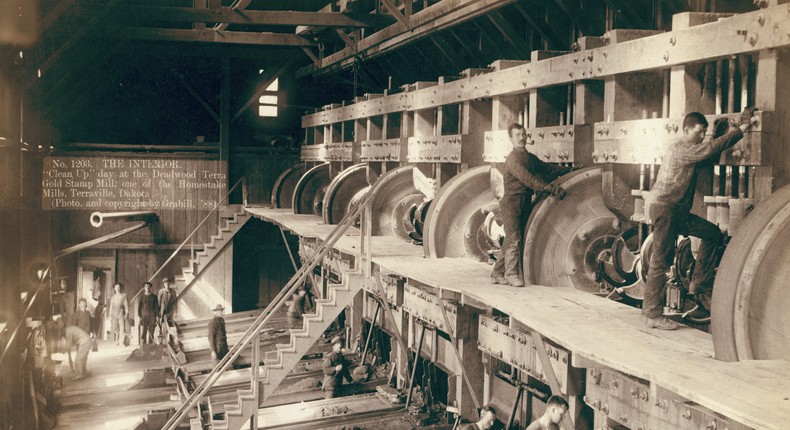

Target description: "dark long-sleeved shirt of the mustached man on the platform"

left=502, top=148, right=569, bottom=196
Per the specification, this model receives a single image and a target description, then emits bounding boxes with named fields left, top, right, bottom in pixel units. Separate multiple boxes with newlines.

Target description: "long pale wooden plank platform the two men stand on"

left=247, top=208, right=790, bottom=429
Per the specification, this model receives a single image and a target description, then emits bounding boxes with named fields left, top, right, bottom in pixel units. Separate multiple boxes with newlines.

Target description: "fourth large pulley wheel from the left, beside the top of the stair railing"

left=370, top=166, right=425, bottom=241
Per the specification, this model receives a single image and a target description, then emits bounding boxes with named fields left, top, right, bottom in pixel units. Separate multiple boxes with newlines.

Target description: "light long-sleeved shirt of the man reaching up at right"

left=651, top=127, right=743, bottom=211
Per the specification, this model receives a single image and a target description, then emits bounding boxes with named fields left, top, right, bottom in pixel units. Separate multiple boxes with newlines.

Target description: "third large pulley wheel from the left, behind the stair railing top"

left=323, top=163, right=369, bottom=224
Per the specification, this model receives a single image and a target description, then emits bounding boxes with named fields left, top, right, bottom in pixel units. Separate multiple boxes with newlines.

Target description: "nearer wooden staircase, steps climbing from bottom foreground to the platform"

left=210, top=272, right=363, bottom=430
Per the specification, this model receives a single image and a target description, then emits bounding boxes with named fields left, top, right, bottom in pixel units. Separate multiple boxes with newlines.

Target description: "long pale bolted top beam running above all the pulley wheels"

left=302, top=5, right=790, bottom=127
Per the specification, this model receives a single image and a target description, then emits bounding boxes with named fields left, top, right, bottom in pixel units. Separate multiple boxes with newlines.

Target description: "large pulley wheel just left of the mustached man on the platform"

left=423, top=166, right=498, bottom=261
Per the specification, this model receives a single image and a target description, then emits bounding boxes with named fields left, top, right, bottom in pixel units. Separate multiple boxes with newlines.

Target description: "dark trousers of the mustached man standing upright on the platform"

left=491, top=194, right=532, bottom=279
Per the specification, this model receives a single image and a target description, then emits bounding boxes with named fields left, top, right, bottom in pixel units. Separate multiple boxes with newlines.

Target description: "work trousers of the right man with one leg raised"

left=642, top=203, right=721, bottom=318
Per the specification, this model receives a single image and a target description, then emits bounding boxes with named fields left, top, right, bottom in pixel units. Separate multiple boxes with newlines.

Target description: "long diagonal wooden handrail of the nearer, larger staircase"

left=162, top=183, right=373, bottom=430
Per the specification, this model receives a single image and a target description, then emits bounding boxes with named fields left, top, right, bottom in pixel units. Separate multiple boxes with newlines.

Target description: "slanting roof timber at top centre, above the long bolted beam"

left=296, top=0, right=516, bottom=77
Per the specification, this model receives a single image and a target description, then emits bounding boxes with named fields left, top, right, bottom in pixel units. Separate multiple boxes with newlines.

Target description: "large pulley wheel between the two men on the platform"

left=523, top=167, right=628, bottom=292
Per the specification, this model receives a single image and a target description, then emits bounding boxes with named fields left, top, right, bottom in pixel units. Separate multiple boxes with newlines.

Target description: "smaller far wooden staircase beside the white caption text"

left=175, top=205, right=252, bottom=299
